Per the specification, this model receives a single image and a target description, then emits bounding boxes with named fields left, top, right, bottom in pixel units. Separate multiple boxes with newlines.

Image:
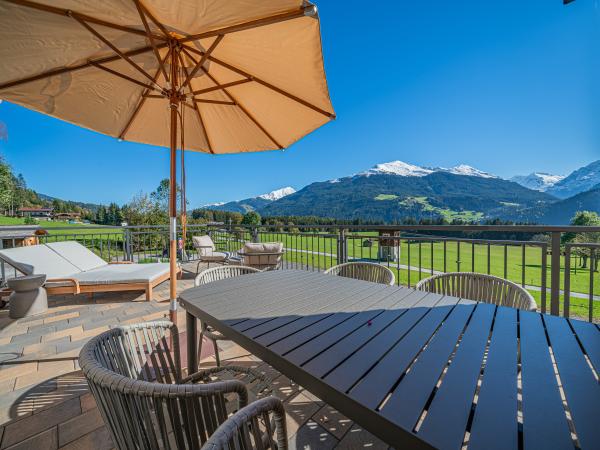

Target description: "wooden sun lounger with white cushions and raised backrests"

left=0, top=241, right=178, bottom=300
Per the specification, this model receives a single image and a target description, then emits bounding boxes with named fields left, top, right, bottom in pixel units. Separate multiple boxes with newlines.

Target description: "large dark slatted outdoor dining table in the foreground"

left=180, top=270, right=600, bottom=450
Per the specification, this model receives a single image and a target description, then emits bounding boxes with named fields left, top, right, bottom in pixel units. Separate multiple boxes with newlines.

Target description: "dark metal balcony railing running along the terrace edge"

left=0, top=225, right=600, bottom=322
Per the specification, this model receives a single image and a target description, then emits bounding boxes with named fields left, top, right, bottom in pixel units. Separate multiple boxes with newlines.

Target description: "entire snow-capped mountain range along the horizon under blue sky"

left=204, top=161, right=600, bottom=224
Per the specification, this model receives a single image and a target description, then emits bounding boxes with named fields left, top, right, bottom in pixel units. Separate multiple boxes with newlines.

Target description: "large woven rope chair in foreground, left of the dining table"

left=79, top=321, right=270, bottom=450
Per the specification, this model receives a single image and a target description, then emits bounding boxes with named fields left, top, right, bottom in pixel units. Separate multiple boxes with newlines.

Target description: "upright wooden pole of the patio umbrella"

left=169, top=43, right=180, bottom=324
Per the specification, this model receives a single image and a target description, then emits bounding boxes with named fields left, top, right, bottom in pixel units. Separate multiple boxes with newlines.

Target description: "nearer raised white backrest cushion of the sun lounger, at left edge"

left=0, top=245, right=81, bottom=278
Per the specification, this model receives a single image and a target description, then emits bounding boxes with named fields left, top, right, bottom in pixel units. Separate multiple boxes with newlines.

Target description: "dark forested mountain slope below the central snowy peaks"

left=259, top=171, right=555, bottom=222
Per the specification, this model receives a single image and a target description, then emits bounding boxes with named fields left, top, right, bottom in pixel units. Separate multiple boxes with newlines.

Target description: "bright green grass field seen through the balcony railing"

left=0, top=216, right=600, bottom=318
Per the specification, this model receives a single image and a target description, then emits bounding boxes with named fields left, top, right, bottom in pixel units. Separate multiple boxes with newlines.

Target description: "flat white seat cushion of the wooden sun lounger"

left=73, top=263, right=169, bottom=285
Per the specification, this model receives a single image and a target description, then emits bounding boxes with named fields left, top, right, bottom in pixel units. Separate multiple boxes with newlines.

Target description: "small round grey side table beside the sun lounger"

left=6, top=275, right=48, bottom=319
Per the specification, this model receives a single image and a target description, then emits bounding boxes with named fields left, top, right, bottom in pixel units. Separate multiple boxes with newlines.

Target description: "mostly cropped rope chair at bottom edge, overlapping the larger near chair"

left=202, top=397, right=288, bottom=450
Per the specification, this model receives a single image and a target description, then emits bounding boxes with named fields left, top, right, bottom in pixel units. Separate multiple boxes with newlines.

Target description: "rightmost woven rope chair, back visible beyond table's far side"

left=416, top=272, right=537, bottom=311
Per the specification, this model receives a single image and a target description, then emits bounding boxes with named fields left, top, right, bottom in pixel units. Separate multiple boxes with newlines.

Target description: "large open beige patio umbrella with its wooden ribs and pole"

left=0, top=0, right=335, bottom=320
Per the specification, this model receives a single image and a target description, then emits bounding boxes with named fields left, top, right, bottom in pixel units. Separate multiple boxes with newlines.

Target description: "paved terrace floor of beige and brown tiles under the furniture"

left=0, top=264, right=388, bottom=450
